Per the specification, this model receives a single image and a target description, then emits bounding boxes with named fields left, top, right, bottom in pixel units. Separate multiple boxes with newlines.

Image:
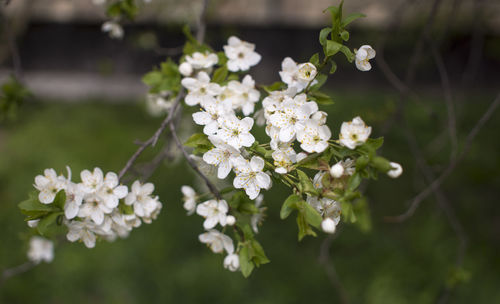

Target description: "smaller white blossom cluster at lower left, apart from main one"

left=24, top=167, right=162, bottom=249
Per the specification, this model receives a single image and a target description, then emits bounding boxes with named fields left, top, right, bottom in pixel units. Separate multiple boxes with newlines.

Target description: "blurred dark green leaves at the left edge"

left=0, top=77, right=31, bottom=122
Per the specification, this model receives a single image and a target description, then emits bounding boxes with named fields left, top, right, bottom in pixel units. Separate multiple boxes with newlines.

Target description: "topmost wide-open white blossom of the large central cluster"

left=224, top=36, right=261, bottom=72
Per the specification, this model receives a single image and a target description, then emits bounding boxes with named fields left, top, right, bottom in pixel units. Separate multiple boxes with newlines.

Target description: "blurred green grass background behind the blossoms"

left=0, top=90, right=500, bottom=303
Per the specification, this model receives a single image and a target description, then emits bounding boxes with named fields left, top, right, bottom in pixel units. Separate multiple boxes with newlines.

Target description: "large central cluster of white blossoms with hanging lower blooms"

left=170, top=29, right=402, bottom=275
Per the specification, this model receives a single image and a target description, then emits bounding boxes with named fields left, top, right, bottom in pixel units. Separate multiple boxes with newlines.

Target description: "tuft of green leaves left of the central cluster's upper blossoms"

left=142, top=58, right=181, bottom=94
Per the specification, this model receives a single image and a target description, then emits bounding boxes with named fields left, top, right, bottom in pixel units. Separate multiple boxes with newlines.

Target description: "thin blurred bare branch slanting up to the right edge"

left=386, top=93, right=500, bottom=223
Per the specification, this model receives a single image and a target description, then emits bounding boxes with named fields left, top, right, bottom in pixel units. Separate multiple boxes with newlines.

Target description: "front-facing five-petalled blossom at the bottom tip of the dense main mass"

left=233, top=156, right=271, bottom=200
